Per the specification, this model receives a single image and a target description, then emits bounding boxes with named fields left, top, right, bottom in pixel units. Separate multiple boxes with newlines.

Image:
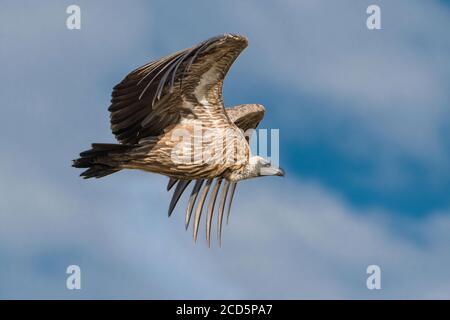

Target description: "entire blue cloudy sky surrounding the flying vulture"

left=0, top=0, right=450, bottom=299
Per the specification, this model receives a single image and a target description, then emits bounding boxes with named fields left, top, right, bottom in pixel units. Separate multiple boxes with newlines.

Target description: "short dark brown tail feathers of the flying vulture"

left=72, top=143, right=131, bottom=179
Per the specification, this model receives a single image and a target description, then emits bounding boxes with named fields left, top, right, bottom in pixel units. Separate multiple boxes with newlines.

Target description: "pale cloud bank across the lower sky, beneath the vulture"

left=0, top=161, right=450, bottom=299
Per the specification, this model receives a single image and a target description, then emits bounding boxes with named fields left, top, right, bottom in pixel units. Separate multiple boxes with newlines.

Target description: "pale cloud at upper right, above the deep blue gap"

left=213, top=1, right=450, bottom=184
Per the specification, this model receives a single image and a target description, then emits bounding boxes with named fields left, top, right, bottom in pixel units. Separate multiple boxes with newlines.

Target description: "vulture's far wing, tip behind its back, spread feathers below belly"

left=167, top=104, right=265, bottom=245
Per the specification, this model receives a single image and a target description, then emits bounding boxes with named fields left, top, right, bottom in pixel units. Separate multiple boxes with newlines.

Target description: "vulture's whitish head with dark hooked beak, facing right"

left=227, top=156, right=284, bottom=182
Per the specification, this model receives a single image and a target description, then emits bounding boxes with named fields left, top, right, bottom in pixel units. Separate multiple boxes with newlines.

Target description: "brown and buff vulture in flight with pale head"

left=73, top=34, right=284, bottom=245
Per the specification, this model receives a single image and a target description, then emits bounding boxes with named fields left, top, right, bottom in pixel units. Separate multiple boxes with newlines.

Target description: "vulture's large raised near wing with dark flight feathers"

left=108, top=34, right=247, bottom=144
